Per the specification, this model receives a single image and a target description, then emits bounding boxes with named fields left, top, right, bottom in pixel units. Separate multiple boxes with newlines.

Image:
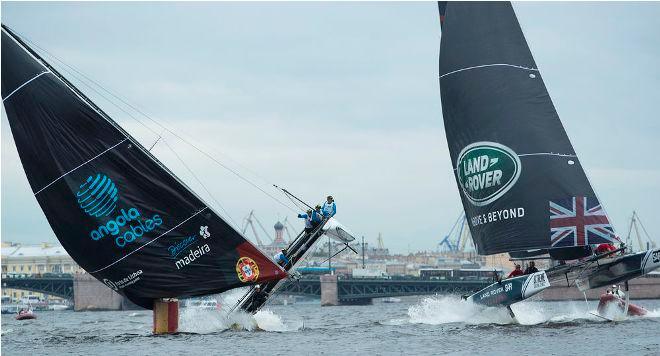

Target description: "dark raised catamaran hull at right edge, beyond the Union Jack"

left=575, top=249, right=660, bottom=291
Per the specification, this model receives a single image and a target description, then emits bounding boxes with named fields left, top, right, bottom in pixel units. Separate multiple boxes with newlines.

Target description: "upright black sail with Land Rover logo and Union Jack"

left=439, top=2, right=616, bottom=255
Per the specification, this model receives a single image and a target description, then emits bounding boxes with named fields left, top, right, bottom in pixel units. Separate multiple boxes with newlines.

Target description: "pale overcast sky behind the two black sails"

left=2, top=1, right=660, bottom=252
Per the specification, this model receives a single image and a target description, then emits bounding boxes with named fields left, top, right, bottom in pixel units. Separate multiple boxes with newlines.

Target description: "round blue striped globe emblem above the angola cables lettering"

left=76, top=173, right=119, bottom=218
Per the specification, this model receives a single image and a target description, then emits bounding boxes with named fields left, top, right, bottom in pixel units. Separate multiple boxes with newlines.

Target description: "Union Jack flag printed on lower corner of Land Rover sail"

left=550, top=197, right=620, bottom=247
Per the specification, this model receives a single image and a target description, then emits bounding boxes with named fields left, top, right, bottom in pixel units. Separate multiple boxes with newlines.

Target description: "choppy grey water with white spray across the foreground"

left=2, top=297, right=660, bottom=356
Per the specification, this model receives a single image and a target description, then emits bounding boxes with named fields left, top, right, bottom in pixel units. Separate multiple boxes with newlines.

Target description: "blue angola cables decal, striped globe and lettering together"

left=76, top=173, right=163, bottom=247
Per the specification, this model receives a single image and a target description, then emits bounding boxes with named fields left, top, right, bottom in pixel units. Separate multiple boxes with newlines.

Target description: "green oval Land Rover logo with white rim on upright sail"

left=456, top=141, right=521, bottom=206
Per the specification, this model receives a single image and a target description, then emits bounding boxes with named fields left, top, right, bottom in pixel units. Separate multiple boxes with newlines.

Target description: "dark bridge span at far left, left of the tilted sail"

left=2, top=273, right=73, bottom=299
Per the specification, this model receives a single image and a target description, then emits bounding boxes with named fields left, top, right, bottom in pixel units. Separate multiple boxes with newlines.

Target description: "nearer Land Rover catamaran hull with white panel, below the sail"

left=467, top=271, right=550, bottom=307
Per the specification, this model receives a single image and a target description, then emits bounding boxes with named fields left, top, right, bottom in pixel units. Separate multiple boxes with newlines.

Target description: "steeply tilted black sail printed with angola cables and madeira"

left=2, top=25, right=286, bottom=308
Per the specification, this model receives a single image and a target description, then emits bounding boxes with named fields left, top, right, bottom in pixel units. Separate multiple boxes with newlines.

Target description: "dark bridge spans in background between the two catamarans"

left=278, top=277, right=490, bottom=304
